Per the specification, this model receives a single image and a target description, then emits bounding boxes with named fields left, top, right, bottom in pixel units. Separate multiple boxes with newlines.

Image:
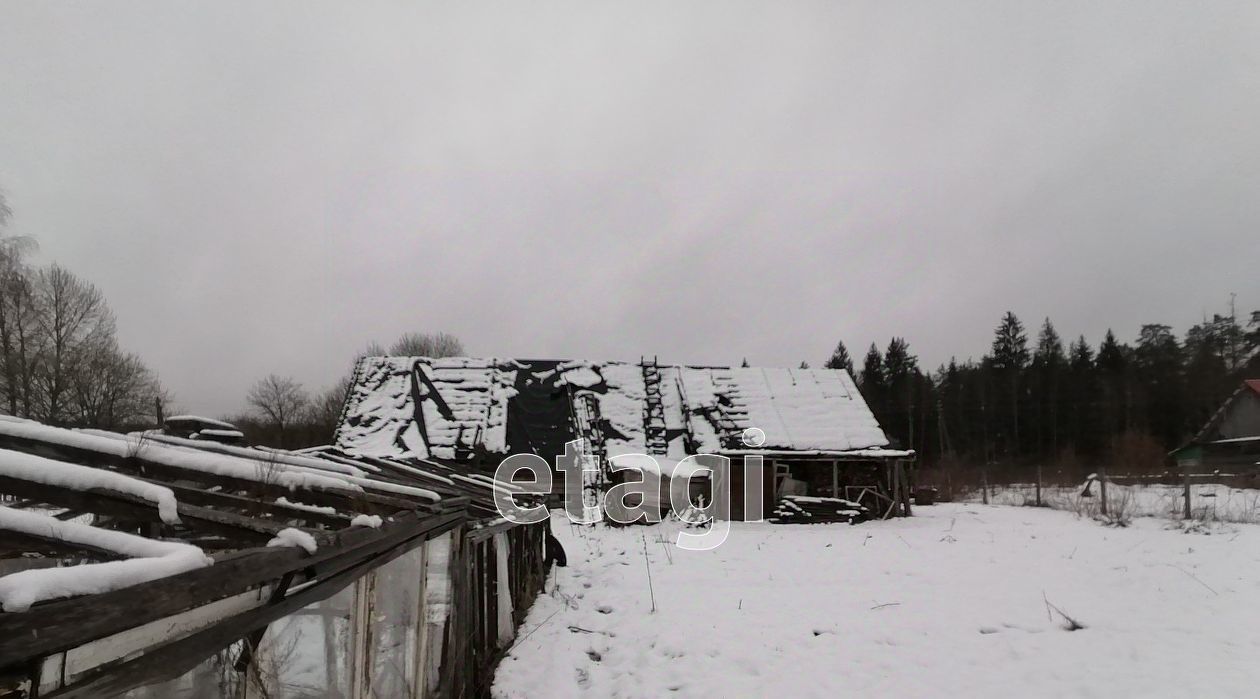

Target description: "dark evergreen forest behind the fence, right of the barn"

left=816, top=310, right=1260, bottom=474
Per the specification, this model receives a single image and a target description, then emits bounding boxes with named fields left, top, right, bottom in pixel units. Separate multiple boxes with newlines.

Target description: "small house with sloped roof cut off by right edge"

left=1172, top=379, right=1260, bottom=475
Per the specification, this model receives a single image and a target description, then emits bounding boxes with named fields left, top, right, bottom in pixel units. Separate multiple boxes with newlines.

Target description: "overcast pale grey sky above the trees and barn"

left=0, top=0, right=1260, bottom=414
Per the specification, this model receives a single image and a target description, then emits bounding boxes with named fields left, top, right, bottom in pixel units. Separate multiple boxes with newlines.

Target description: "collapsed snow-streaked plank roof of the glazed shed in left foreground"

left=0, top=416, right=534, bottom=696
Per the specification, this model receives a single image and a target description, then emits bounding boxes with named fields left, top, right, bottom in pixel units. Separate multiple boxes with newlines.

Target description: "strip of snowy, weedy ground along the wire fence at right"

left=965, top=482, right=1260, bottom=524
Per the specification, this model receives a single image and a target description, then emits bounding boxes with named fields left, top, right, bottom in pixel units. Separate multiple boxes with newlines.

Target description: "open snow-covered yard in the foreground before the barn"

left=494, top=504, right=1260, bottom=699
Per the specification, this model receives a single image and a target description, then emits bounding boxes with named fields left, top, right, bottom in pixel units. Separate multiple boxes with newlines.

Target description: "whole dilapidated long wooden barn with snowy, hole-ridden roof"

left=334, top=356, right=915, bottom=520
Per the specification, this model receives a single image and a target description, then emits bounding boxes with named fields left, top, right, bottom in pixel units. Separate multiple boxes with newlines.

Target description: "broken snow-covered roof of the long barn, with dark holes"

left=335, top=356, right=910, bottom=460
